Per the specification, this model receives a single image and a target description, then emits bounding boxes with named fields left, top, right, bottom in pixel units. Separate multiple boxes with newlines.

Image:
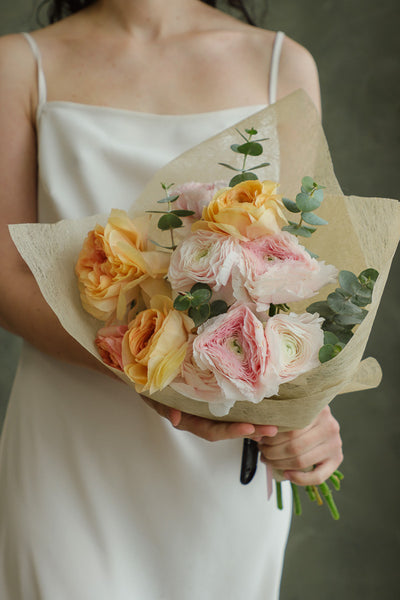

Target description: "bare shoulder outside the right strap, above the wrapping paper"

left=278, top=36, right=321, bottom=112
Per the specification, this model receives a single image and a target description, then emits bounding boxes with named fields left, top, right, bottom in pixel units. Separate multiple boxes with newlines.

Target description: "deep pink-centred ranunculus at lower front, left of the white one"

left=193, top=304, right=279, bottom=412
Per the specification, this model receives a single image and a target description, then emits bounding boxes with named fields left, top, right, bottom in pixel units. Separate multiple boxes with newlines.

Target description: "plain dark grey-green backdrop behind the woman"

left=0, top=0, right=400, bottom=600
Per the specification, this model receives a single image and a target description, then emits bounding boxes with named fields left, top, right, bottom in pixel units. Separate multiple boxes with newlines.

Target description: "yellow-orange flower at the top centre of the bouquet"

left=192, top=180, right=287, bottom=240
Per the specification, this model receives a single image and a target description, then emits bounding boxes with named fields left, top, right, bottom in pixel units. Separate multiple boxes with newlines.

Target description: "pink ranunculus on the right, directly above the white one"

left=233, top=231, right=338, bottom=310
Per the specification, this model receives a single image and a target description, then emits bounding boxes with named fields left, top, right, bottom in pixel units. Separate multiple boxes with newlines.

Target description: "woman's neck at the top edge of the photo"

left=93, top=0, right=203, bottom=39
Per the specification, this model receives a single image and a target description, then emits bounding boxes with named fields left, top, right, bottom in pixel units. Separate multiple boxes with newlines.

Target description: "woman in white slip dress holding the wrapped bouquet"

left=0, top=0, right=342, bottom=600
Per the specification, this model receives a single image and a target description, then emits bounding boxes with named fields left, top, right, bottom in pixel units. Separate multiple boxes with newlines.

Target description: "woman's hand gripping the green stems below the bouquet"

left=258, top=406, right=343, bottom=485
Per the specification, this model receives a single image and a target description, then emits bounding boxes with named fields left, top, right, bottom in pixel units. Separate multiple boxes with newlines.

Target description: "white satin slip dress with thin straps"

left=0, top=37, right=291, bottom=600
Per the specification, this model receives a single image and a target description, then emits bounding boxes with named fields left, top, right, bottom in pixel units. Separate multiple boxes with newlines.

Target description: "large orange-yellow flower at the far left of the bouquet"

left=75, top=209, right=169, bottom=321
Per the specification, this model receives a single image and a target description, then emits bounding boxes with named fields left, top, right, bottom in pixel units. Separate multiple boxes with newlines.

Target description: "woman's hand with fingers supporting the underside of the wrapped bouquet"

left=141, top=396, right=278, bottom=442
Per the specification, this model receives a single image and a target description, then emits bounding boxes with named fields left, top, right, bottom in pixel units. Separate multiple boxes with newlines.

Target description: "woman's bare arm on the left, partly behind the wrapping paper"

left=0, top=35, right=104, bottom=371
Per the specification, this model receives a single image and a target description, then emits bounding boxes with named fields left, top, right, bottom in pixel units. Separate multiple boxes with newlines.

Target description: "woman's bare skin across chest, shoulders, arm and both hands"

left=0, top=0, right=343, bottom=485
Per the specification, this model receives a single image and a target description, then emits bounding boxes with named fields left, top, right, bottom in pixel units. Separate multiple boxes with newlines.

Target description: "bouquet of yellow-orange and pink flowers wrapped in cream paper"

left=11, top=91, right=400, bottom=514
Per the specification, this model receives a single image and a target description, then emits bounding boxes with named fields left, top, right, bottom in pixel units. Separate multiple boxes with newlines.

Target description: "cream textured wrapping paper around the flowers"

left=10, top=90, right=400, bottom=429
